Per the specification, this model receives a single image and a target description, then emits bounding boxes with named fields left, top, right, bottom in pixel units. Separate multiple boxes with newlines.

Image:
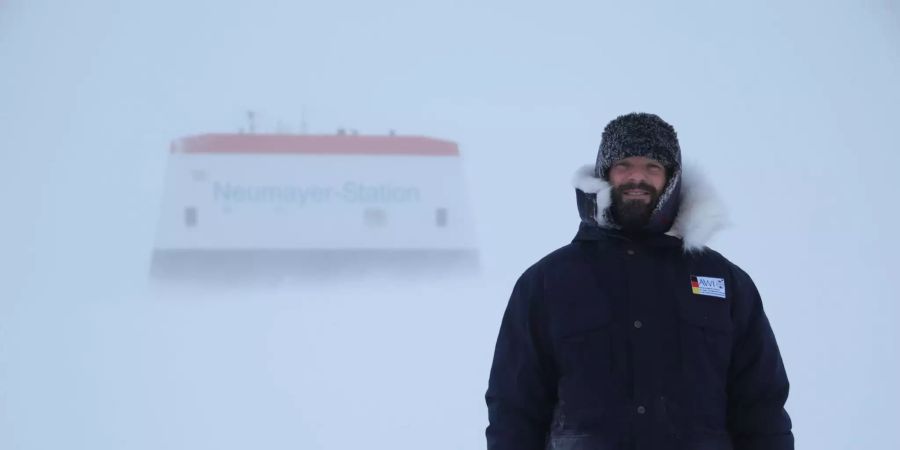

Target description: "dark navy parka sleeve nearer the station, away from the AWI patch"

left=485, top=269, right=556, bottom=450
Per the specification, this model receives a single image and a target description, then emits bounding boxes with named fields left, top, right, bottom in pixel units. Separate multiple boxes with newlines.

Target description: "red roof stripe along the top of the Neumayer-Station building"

left=171, top=134, right=459, bottom=156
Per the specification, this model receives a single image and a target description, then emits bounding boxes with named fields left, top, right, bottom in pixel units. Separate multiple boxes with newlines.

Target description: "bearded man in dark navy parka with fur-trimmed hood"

left=485, top=113, right=794, bottom=450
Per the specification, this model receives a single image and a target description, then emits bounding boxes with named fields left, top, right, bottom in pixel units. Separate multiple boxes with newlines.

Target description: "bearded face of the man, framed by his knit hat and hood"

left=609, top=156, right=668, bottom=230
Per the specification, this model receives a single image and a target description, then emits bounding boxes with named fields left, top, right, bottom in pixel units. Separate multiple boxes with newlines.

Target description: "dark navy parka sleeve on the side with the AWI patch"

left=728, top=268, right=794, bottom=450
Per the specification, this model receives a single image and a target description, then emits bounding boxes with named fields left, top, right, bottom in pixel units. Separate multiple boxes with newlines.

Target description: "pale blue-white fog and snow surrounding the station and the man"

left=0, top=0, right=900, bottom=450
